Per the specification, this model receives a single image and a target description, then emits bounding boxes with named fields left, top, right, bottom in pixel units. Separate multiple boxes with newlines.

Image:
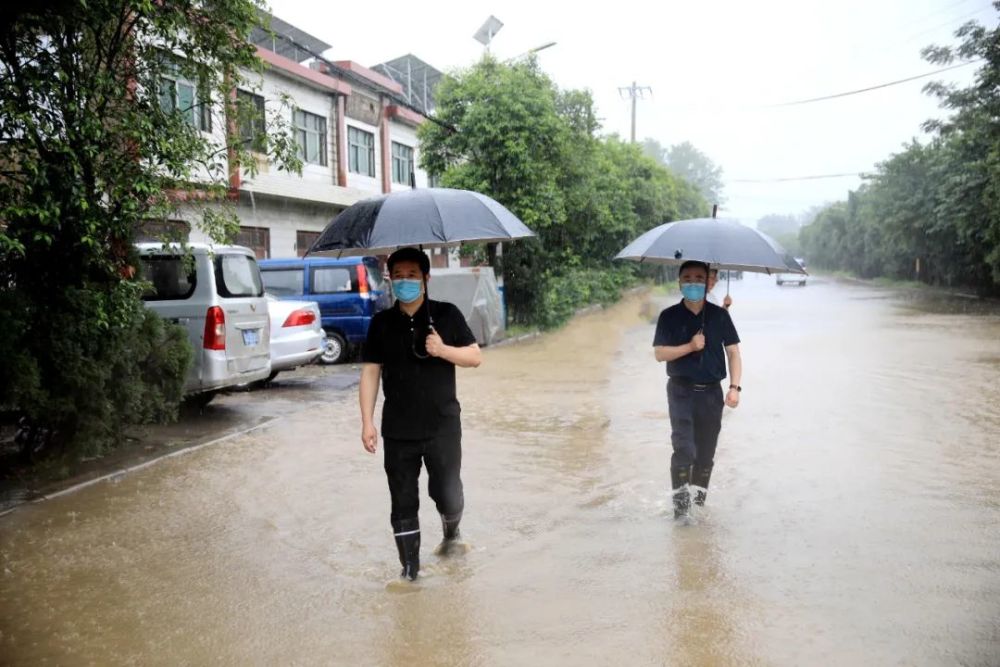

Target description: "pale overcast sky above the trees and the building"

left=271, top=0, right=997, bottom=223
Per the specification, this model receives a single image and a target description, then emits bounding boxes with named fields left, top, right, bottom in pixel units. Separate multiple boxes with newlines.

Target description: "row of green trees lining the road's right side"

left=800, top=2, right=1000, bottom=293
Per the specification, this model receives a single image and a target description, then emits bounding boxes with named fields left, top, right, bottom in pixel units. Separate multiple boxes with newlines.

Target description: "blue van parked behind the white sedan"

left=259, top=257, right=392, bottom=364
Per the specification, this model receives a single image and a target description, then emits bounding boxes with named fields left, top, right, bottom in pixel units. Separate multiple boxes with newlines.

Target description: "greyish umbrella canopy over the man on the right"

left=615, top=218, right=806, bottom=274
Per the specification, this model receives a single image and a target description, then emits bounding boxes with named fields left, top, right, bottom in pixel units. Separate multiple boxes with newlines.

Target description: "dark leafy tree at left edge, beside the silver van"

left=0, top=0, right=298, bottom=460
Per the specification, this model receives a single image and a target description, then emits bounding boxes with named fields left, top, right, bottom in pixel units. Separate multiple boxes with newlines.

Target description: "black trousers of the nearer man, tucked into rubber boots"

left=383, top=430, right=465, bottom=521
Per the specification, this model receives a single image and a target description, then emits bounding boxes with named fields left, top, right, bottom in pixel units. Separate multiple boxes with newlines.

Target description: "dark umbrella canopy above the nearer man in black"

left=307, top=188, right=535, bottom=257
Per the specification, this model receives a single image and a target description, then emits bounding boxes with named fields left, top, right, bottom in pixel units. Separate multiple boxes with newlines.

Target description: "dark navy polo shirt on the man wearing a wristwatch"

left=653, top=299, right=740, bottom=384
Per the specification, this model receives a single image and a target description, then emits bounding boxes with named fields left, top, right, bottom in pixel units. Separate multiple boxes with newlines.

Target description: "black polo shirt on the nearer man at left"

left=362, top=300, right=476, bottom=440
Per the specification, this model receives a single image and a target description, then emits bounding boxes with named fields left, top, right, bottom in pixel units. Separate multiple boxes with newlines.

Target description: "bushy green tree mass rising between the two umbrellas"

left=420, top=58, right=706, bottom=326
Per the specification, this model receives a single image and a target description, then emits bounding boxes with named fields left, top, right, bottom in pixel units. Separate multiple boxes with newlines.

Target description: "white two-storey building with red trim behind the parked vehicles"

left=170, top=12, right=448, bottom=266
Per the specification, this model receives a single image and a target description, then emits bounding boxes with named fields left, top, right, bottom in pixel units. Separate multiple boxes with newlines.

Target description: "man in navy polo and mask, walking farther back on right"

left=653, top=262, right=743, bottom=519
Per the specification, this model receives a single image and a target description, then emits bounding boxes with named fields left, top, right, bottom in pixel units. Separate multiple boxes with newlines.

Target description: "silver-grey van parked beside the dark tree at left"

left=137, top=243, right=271, bottom=405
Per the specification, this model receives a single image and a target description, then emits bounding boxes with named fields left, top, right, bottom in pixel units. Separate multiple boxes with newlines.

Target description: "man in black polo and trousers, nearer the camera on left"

left=360, top=248, right=481, bottom=581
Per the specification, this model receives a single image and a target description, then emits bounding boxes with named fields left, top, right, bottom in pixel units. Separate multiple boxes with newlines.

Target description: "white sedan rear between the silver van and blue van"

left=267, top=294, right=326, bottom=380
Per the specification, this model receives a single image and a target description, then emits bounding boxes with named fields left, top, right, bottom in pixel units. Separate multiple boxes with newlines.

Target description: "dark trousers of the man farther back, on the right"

left=667, top=378, right=725, bottom=468
